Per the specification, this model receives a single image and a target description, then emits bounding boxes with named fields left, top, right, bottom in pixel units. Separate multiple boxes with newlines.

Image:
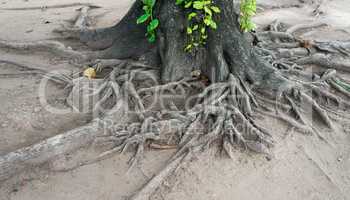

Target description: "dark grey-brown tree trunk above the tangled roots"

left=86, top=0, right=286, bottom=89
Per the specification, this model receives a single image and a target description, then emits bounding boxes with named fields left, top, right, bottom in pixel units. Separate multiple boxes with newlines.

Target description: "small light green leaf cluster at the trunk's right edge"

left=239, top=0, right=256, bottom=32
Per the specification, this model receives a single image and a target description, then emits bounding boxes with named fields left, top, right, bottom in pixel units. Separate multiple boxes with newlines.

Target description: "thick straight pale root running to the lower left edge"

left=0, top=92, right=128, bottom=183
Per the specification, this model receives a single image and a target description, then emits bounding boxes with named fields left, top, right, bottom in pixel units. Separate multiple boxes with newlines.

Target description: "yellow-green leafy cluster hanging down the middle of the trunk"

left=176, top=0, right=220, bottom=52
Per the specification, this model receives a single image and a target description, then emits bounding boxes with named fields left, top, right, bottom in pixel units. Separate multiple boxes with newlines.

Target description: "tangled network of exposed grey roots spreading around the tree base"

left=0, top=4, right=350, bottom=200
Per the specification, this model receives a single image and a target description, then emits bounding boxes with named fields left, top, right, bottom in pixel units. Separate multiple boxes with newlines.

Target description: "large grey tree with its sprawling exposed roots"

left=0, top=0, right=350, bottom=199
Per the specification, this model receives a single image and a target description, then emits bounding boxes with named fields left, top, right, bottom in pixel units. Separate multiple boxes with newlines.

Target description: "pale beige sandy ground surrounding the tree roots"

left=0, top=0, right=350, bottom=200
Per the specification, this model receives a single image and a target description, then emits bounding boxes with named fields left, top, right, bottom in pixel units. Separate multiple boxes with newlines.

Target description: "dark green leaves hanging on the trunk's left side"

left=137, top=0, right=159, bottom=43
